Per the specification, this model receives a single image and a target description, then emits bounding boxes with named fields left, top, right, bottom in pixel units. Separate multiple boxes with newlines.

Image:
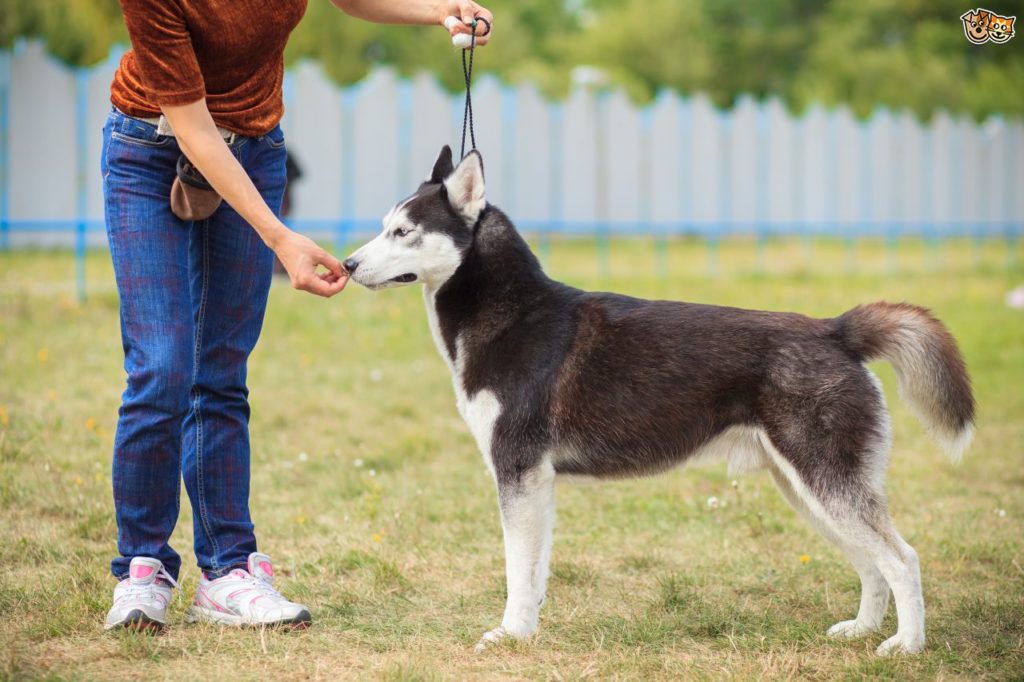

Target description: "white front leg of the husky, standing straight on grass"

left=476, top=462, right=555, bottom=651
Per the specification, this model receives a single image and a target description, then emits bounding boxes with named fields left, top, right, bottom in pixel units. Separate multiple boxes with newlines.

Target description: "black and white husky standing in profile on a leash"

left=345, top=146, right=975, bottom=655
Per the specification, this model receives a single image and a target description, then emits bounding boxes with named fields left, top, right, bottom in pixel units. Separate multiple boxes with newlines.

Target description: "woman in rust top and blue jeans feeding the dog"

left=101, top=0, right=492, bottom=629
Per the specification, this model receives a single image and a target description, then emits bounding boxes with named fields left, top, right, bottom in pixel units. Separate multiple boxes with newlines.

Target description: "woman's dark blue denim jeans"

left=101, top=111, right=286, bottom=579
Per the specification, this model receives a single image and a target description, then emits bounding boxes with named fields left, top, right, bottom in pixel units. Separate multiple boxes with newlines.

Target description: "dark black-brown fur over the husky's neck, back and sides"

left=410, top=164, right=973, bottom=499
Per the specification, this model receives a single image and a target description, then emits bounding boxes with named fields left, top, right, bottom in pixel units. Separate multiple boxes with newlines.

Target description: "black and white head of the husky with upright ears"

left=345, top=145, right=486, bottom=290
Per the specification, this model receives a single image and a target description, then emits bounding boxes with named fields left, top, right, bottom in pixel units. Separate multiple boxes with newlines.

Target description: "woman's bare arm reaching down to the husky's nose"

left=161, top=99, right=348, bottom=297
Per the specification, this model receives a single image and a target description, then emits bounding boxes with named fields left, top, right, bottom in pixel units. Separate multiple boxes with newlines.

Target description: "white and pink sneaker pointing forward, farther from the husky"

left=103, top=556, right=178, bottom=630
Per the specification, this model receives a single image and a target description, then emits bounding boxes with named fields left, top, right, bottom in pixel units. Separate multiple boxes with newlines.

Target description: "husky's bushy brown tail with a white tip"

left=836, top=303, right=975, bottom=462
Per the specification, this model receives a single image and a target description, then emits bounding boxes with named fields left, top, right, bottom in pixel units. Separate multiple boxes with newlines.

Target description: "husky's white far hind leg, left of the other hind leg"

left=769, top=456, right=889, bottom=639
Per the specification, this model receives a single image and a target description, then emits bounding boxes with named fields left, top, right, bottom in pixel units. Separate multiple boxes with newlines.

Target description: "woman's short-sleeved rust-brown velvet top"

left=111, top=0, right=307, bottom=136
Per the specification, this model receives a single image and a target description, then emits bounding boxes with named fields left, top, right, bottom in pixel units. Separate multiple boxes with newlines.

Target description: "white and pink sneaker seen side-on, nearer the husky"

left=185, top=552, right=312, bottom=628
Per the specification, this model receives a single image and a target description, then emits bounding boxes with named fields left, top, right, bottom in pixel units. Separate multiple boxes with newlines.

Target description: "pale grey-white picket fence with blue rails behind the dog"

left=0, top=42, right=1024, bottom=245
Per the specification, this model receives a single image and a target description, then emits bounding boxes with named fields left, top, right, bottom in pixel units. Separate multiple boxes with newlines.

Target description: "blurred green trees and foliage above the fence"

left=0, top=0, right=1024, bottom=119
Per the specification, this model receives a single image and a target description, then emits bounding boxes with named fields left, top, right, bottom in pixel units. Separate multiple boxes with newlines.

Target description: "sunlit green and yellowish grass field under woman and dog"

left=0, top=241, right=1024, bottom=680
